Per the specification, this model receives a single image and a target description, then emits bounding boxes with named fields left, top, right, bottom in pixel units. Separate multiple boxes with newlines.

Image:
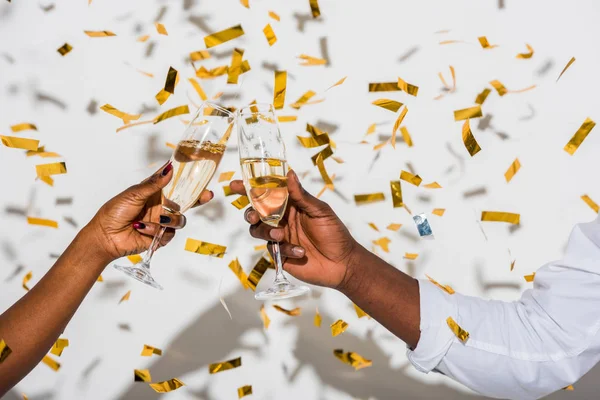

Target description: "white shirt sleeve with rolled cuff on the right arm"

left=408, top=220, right=600, bottom=399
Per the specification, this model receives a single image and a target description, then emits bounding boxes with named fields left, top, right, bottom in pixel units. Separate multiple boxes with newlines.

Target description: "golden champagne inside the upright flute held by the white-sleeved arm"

left=241, top=158, right=288, bottom=226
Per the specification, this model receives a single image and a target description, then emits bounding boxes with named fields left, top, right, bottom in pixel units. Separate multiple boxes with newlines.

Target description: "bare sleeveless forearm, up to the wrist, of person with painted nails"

left=0, top=226, right=111, bottom=397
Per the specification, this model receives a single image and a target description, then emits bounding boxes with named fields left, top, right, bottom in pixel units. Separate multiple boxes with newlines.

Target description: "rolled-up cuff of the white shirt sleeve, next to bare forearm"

left=406, top=279, right=460, bottom=373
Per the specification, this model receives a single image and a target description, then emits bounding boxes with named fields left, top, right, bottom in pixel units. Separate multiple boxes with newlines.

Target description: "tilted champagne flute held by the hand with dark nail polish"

left=114, top=102, right=234, bottom=290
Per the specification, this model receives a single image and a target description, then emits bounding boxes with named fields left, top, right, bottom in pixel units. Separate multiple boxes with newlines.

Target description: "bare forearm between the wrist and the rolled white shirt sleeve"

left=339, top=244, right=421, bottom=348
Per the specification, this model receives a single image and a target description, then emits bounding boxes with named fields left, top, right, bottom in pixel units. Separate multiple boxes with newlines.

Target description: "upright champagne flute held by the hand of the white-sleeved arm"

left=237, top=104, right=310, bottom=300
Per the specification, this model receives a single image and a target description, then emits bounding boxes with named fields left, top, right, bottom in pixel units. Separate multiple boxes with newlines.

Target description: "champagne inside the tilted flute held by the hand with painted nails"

left=162, top=140, right=225, bottom=214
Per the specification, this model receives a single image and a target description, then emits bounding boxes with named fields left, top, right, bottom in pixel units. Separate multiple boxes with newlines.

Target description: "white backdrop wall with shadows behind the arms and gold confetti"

left=0, top=0, right=600, bottom=400
